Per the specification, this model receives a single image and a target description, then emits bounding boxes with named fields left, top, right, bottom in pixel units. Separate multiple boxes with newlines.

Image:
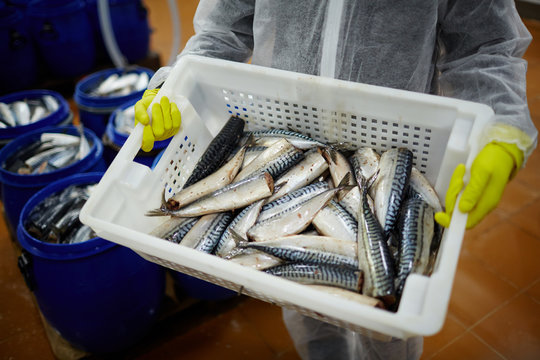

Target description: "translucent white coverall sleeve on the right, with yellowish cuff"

left=437, top=0, right=538, bottom=160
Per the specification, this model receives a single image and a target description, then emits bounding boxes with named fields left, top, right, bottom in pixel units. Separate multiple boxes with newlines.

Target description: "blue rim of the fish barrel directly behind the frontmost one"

left=0, top=125, right=103, bottom=187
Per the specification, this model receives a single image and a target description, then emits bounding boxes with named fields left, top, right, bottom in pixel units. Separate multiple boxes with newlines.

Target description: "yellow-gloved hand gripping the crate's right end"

left=435, top=142, right=523, bottom=229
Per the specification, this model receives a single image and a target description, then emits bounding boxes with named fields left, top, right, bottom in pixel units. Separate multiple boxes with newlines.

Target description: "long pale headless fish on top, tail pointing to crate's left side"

left=147, top=173, right=274, bottom=217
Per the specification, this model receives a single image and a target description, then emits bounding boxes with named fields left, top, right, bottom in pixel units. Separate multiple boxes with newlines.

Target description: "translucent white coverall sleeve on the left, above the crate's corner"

left=148, top=0, right=255, bottom=89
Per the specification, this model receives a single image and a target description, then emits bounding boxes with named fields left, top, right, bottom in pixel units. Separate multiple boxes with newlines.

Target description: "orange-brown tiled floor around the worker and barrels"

left=0, top=0, right=540, bottom=360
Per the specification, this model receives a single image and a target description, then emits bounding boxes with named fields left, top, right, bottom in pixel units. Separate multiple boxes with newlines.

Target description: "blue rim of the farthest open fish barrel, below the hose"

left=73, top=66, right=154, bottom=113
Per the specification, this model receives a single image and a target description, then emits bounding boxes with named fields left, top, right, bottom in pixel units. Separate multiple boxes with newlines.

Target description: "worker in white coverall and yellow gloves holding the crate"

left=136, top=0, right=538, bottom=359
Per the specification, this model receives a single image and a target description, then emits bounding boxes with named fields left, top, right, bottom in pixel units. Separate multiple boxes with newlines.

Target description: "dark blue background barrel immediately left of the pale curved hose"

left=26, top=0, right=96, bottom=77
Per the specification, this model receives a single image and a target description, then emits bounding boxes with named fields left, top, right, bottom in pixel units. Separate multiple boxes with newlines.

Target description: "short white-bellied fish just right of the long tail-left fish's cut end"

left=268, top=151, right=328, bottom=202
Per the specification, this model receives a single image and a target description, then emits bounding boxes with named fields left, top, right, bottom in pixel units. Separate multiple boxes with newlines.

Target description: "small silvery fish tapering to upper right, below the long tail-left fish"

left=215, top=199, right=264, bottom=257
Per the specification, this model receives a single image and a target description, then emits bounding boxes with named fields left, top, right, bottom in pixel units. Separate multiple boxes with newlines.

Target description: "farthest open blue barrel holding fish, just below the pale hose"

left=73, top=67, right=154, bottom=138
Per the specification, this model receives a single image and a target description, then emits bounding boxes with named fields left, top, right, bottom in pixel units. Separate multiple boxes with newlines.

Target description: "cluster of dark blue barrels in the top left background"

left=0, top=0, right=150, bottom=94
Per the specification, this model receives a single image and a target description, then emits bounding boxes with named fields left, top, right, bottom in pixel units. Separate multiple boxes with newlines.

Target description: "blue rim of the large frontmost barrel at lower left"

left=17, top=172, right=115, bottom=261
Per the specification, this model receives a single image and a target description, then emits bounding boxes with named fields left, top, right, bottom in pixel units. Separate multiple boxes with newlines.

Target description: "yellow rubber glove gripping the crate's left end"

left=135, top=89, right=182, bottom=152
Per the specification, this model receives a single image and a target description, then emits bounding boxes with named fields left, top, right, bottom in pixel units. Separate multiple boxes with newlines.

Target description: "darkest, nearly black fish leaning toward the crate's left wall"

left=184, top=116, right=244, bottom=188
